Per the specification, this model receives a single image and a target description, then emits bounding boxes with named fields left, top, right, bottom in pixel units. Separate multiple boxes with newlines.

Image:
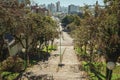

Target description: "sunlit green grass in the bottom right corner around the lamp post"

left=82, top=61, right=120, bottom=80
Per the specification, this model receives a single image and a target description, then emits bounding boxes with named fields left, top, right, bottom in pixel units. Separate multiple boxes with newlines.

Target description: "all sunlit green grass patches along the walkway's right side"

left=75, top=48, right=120, bottom=80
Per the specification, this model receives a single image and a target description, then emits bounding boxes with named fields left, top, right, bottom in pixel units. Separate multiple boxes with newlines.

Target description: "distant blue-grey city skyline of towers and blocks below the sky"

left=32, top=1, right=101, bottom=15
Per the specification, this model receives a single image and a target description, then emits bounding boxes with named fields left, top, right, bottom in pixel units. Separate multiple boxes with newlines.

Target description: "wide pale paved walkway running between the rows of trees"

left=25, top=27, right=87, bottom=80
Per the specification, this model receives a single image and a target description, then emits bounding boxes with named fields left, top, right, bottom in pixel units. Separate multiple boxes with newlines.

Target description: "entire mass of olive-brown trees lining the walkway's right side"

left=71, top=0, right=120, bottom=80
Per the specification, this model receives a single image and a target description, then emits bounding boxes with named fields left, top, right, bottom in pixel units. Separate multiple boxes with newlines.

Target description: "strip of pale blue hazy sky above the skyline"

left=31, top=0, right=104, bottom=6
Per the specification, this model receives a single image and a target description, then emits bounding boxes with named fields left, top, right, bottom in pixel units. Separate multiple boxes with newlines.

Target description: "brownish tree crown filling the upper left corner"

left=0, top=0, right=29, bottom=61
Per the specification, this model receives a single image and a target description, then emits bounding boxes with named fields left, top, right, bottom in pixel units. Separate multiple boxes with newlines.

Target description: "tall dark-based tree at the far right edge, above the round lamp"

left=99, top=0, right=120, bottom=80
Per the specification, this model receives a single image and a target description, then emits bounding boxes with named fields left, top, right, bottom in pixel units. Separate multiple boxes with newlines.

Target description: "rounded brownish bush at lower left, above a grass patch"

left=1, top=56, right=24, bottom=72
